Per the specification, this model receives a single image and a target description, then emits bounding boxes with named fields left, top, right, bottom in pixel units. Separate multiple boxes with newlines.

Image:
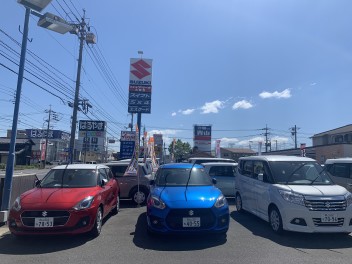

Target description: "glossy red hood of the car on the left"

left=21, top=187, right=98, bottom=209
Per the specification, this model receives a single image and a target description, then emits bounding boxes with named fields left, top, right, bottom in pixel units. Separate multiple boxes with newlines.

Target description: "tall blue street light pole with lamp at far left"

left=0, top=0, right=67, bottom=217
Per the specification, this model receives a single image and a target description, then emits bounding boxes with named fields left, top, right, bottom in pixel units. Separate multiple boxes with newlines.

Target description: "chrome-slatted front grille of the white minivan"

left=305, top=198, right=347, bottom=211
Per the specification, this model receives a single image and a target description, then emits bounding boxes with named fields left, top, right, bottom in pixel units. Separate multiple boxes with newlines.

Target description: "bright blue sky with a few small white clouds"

left=0, top=0, right=352, bottom=153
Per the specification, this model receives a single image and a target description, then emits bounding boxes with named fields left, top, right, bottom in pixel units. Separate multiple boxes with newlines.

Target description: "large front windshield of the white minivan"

left=269, top=161, right=334, bottom=185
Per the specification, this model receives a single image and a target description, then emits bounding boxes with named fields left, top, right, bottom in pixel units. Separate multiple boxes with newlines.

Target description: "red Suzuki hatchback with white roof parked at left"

left=8, top=164, right=120, bottom=236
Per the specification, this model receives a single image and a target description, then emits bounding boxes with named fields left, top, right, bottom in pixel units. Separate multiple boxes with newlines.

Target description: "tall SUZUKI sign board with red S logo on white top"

left=128, top=59, right=152, bottom=114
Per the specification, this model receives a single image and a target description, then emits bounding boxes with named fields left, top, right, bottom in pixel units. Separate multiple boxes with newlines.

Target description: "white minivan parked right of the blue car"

left=235, top=155, right=352, bottom=233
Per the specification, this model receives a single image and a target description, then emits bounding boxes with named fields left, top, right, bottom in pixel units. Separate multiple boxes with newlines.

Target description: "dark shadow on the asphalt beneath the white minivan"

left=230, top=208, right=352, bottom=250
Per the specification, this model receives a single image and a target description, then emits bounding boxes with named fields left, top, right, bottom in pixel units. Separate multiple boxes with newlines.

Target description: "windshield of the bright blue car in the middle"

left=155, top=168, right=213, bottom=186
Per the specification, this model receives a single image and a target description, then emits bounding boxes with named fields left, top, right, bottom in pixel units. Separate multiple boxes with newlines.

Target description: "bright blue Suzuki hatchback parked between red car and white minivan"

left=147, top=163, right=229, bottom=234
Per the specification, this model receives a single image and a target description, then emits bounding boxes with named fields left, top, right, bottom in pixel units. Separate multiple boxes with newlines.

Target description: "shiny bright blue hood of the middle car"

left=152, top=186, right=221, bottom=208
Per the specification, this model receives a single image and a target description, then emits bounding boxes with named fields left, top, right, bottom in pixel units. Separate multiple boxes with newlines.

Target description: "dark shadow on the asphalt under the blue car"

left=131, top=213, right=227, bottom=251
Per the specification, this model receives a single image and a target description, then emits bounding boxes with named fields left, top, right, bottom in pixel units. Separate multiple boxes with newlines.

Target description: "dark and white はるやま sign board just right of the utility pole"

left=78, top=120, right=106, bottom=152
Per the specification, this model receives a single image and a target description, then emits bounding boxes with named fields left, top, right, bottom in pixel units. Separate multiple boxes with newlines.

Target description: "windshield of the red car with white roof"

left=40, top=169, right=98, bottom=188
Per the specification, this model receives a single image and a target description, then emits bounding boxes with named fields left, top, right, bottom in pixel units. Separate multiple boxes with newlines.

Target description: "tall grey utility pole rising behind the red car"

left=69, top=10, right=95, bottom=163
